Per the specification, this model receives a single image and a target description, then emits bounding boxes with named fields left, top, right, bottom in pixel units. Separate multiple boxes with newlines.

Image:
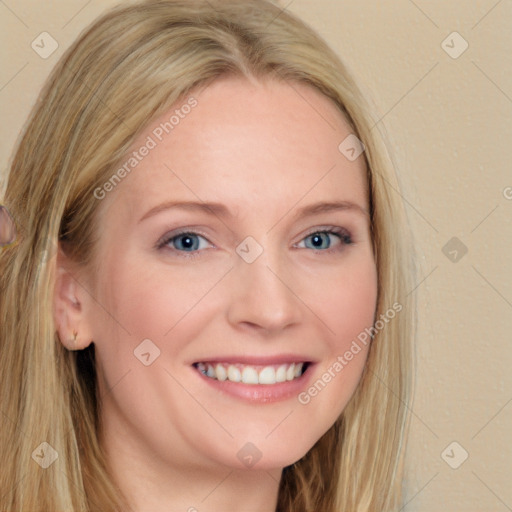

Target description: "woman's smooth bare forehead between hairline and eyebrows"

left=99, top=78, right=367, bottom=222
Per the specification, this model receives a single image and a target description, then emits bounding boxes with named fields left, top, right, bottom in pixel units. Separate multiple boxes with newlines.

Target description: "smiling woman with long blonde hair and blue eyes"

left=0, top=0, right=413, bottom=512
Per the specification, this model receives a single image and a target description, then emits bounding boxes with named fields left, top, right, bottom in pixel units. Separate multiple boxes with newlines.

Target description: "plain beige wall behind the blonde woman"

left=0, top=0, right=512, bottom=512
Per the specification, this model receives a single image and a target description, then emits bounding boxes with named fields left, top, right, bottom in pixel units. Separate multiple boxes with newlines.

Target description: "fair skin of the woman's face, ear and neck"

left=55, top=78, right=377, bottom=512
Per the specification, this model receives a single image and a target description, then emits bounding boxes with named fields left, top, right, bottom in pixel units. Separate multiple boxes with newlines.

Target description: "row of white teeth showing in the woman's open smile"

left=193, top=362, right=309, bottom=386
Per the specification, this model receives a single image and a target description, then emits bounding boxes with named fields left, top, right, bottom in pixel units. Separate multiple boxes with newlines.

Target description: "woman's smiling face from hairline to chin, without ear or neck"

left=74, top=78, right=377, bottom=469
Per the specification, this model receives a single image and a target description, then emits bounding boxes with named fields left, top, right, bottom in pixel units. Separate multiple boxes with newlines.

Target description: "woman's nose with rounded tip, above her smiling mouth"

left=227, top=251, right=304, bottom=335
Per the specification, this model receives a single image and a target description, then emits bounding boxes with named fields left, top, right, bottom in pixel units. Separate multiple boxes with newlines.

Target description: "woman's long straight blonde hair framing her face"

left=0, top=0, right=415, bottom=512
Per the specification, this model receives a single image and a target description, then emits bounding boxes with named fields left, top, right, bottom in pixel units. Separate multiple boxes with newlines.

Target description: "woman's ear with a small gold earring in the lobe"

left=53, top=244, right=92, bottom=350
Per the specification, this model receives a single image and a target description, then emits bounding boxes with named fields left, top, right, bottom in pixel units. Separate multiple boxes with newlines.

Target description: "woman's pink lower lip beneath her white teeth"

left=192, top=363, right=314, bottom=404
